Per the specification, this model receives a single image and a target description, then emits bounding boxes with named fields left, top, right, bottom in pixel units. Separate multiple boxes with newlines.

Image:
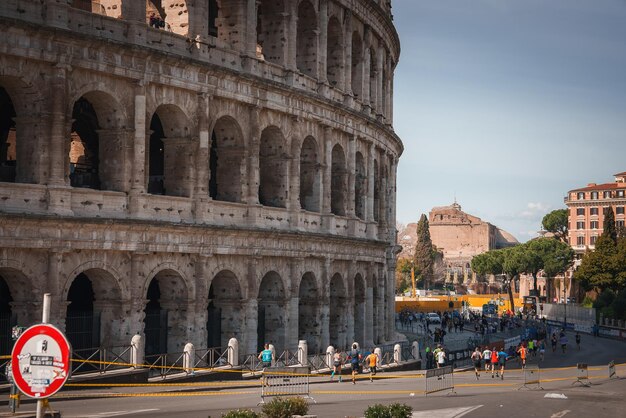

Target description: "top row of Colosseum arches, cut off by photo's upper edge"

left=74, top=0, right=392, bottom=114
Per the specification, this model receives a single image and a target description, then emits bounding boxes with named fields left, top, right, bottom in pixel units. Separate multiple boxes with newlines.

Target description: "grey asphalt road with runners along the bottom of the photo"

left=4, top=335, right=626, bottom=418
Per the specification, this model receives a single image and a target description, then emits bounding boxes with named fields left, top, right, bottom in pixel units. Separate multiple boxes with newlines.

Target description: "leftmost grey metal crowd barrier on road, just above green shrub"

left=259, top=367, right=315, bottom=405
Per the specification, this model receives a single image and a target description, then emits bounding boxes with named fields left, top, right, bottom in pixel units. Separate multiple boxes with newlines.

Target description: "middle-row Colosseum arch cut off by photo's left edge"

left=0, top=76, right=42, bottom=183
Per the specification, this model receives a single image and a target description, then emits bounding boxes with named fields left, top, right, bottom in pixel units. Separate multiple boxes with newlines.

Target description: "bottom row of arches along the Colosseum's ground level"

left=0, top=268, right=384, bottom=355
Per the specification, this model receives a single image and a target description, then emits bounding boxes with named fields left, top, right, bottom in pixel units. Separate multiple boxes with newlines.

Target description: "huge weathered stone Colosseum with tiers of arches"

left=0, top=0, right=403, bottom=355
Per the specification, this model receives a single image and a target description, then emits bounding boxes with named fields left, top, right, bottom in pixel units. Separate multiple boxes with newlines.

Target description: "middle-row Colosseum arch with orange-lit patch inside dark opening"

left=67, top=90, right=126, bottom=191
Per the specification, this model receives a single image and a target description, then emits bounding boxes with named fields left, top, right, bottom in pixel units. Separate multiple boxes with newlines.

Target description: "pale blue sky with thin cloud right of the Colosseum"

left=392, top=0, right=626, bottom=241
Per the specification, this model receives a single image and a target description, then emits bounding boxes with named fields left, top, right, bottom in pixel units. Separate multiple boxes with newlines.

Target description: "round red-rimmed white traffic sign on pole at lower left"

left=11, top=324, right=70, bottom=398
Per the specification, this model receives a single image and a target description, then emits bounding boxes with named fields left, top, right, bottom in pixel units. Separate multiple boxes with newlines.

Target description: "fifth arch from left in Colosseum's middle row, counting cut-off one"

left=259, top=126, right=289, bottom=208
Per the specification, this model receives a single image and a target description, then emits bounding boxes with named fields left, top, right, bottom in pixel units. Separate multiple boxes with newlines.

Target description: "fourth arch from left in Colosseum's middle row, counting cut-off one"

left=209, top=117, right=244, bottom=202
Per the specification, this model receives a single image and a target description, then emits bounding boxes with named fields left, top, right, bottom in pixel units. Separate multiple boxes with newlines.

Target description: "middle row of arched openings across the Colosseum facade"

left=0, top=84, right=388, bottom=221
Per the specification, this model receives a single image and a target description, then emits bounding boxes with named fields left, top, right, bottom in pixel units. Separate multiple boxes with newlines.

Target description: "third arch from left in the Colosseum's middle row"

left=146, top=104, right=195, bottom=197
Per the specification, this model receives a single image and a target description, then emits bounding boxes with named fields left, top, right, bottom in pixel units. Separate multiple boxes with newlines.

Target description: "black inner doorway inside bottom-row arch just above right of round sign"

left=65, top=273, right=100, bottom=351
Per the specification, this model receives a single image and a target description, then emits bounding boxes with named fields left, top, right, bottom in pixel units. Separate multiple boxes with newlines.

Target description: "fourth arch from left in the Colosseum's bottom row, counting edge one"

left=207, top=270, right=243, bottom=349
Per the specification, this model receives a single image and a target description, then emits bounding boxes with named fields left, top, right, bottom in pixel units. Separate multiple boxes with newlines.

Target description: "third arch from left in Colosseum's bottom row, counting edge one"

left=144, top=264, right=190, bottom=356
